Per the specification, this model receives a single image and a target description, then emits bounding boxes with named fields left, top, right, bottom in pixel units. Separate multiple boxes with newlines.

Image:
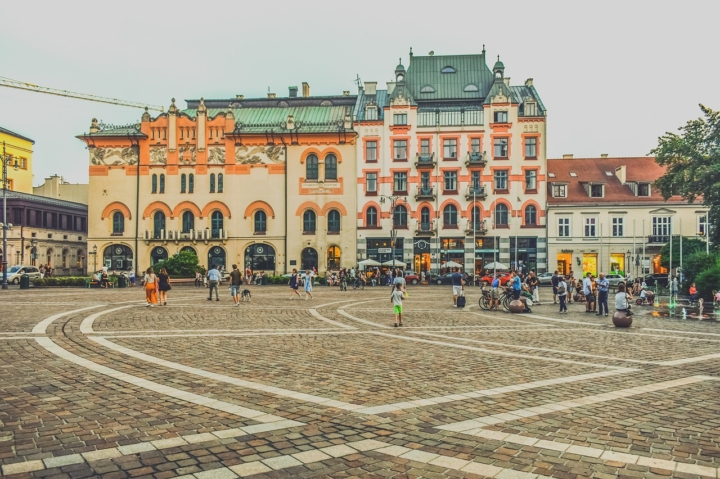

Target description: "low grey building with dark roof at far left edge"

left=0, top=191, right=92, bottom=276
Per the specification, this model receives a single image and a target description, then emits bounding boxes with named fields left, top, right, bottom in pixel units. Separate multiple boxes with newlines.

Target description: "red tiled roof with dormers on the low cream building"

left=547, top=157, right=687, bottom=205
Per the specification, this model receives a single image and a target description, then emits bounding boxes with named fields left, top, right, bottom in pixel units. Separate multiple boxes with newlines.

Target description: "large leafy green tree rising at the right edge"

left=651, top=105, right=720, bottom=245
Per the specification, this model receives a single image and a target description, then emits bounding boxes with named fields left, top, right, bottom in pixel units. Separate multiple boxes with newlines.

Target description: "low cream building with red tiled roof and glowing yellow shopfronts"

left=547, top=155, right=708, bottom=277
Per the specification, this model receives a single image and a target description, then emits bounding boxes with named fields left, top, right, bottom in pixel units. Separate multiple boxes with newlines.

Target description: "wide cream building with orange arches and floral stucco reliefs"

left=79, top=83, right=356, bottom=274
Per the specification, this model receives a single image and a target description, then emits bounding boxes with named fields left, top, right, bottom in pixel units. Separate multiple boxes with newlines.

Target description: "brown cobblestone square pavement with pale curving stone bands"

left=0, top=286, right=720, bottom=479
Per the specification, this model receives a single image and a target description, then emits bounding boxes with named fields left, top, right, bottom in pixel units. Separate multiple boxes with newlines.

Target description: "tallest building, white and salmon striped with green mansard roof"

left=355, top=49, right=547, bottom=272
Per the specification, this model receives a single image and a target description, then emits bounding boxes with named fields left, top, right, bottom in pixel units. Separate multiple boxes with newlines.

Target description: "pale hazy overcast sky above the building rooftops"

left=0, top=0, right=720, bottom=186
